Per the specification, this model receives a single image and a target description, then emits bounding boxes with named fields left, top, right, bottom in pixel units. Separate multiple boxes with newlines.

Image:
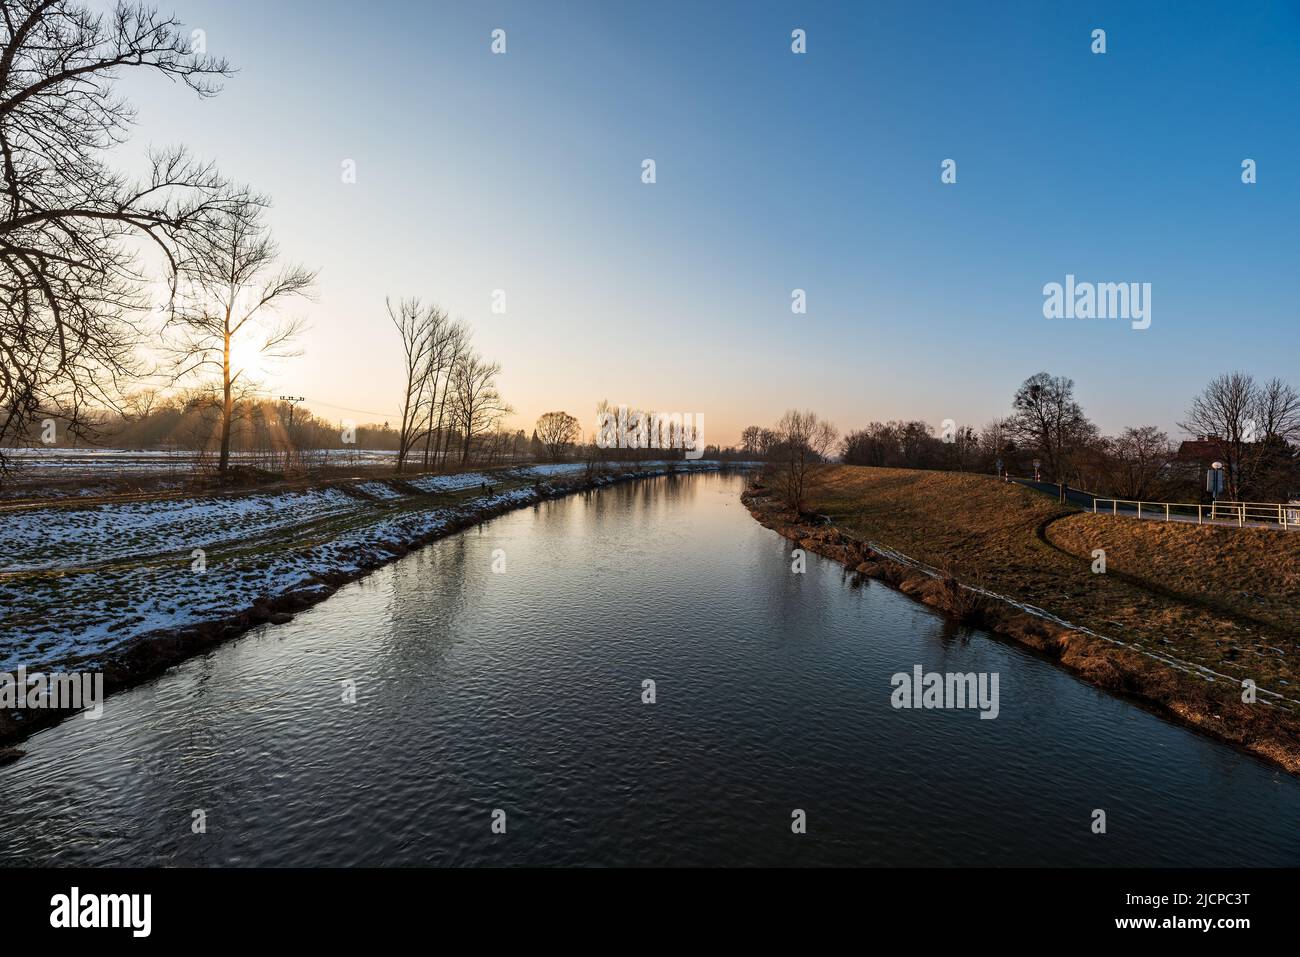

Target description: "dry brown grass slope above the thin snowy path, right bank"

left=809, top=465, right=1300, bottom=698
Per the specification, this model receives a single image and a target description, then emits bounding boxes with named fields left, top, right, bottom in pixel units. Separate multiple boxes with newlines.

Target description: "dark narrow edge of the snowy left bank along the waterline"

left=0, top=462, right=750, bottom=767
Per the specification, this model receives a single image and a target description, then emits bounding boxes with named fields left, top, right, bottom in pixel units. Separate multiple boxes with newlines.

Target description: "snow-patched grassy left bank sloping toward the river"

left=0, top=462, right=718, bottom=671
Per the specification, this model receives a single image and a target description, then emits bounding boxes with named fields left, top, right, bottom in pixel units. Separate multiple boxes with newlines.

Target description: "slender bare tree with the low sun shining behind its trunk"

left=168, top=198, right=316, bottom=472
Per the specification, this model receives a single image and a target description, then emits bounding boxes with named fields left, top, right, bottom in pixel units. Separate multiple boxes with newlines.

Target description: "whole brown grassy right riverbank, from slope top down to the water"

left=751, top=465, right=1300, bottom=770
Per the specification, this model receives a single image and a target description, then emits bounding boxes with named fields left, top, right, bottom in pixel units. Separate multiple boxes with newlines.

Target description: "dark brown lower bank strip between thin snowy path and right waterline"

left=741, top=485, right=1300, bottom=775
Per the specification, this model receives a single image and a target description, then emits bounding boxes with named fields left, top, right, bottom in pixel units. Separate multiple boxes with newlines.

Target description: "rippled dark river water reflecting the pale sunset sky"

left=0, top=475, right=1300, bottom=866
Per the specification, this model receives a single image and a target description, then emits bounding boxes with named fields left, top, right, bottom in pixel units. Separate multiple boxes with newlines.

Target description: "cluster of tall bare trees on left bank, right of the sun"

left=385, top=296, right=517, bottom=472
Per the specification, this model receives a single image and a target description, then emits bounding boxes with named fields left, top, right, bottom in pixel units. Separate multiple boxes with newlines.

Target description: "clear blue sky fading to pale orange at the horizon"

left=106, top=0, right=1300, bottom=443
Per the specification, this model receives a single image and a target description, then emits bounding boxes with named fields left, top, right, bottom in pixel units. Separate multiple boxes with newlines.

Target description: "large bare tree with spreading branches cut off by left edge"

left=0, top=0, right=241, bottom=462
